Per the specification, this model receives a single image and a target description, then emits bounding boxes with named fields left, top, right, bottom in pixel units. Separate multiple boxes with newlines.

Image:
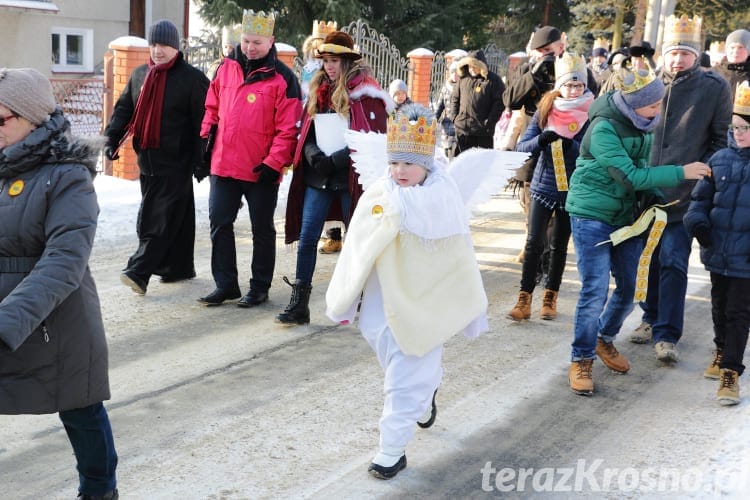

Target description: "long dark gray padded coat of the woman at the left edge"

left=0, top=108, right=110, bottom=414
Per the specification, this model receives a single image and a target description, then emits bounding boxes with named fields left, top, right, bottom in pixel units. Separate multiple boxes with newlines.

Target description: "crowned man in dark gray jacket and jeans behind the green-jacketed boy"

left=630, top=15, right=732, bottom=363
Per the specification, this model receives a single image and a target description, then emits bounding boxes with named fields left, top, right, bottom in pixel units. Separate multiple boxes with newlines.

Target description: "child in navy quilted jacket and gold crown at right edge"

left=684, top=81, right=750, bottom=405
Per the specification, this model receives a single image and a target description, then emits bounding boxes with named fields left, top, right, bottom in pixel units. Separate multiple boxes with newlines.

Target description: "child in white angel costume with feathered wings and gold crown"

left=326, top=105, right=528, bottom=479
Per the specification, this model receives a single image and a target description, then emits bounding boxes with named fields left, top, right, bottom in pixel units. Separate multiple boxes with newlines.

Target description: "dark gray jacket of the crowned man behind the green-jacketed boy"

left=650, top=62, right=732, bottom=222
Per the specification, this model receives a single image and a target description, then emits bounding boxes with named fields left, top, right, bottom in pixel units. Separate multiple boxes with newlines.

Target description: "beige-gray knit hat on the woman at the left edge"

left=0, top=68, right=56, bottom=125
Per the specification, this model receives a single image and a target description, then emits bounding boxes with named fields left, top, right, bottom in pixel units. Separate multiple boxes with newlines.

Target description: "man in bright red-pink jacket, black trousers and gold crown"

left=203, top=10, right=302, bottom=307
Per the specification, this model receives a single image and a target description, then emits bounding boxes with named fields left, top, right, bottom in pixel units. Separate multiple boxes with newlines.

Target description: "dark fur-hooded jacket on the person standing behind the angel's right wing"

left=450, top=50, right=505, bottom=137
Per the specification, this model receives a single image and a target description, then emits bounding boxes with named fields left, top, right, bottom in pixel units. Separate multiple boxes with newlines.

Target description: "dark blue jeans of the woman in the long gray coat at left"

left=59, top=403, right=117, bottom=496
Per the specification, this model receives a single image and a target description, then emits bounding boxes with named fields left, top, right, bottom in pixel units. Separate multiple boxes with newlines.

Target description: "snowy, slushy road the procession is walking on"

left=0, top=194, right=750, bottom=499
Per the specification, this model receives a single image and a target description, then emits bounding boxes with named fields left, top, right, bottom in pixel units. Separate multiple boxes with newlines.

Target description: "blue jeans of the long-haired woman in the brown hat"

left=296, top=186, right=352, bottom=284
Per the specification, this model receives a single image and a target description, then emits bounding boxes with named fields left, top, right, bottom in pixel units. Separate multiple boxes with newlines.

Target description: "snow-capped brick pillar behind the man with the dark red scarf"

left=104, top=36, right=149, bottom=180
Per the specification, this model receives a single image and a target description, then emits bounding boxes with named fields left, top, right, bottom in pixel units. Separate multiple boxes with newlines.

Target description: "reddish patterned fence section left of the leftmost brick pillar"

left=50, top=78, right=104, bottom=135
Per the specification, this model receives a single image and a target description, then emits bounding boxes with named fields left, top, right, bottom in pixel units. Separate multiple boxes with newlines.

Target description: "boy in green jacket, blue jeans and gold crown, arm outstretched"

left=565, top=62, right=709, bottom=396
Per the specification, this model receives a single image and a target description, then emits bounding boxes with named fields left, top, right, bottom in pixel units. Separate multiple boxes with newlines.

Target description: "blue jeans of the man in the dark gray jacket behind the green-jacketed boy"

left=640, top=222, right=693, bottom=344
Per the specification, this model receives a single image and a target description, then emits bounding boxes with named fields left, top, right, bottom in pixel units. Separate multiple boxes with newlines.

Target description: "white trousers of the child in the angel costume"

left=359, top=273, right=443, bottom=456
